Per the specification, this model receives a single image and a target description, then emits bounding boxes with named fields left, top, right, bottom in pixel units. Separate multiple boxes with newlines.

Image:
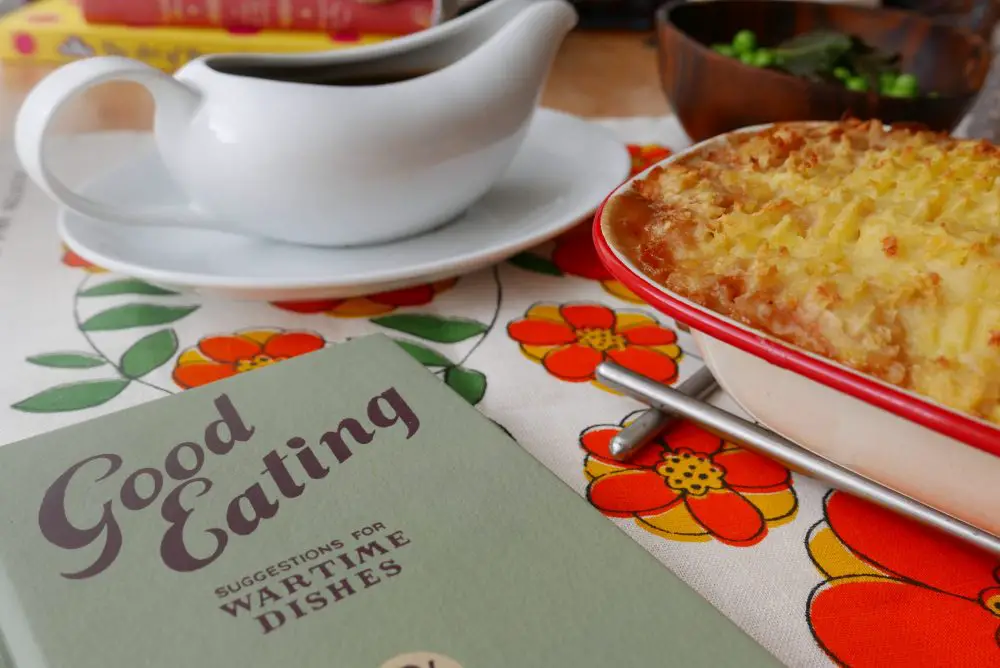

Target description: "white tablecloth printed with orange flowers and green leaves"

left=0, top=119, right=1000, bottom=668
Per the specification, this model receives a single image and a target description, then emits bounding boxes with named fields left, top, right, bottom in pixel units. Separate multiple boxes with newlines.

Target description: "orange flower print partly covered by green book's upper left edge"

left=173, top=329, right=326, bottom=389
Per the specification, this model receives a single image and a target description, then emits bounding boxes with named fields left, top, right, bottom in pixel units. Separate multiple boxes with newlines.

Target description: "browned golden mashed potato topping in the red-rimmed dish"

left=604, top=121, right=1000, bottom=423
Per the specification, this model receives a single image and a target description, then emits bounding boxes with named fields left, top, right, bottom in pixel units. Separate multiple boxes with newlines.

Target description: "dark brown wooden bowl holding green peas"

left=656, top=0, right=991, bottom=142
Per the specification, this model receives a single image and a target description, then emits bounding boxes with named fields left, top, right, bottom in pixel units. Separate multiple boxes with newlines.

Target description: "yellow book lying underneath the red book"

left=0, top=0, right=393, bottom=72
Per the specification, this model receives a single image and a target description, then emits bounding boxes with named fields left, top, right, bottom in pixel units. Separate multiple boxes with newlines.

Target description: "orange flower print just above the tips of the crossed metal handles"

left=507, top=304, right=681, bottom=387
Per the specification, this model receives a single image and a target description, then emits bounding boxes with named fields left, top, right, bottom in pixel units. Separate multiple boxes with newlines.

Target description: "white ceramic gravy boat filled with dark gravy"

left=15, top=0, right=577, bottom=246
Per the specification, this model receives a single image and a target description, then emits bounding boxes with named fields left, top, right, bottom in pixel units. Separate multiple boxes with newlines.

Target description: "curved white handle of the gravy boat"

left=14, top=56, right=211, bottom=227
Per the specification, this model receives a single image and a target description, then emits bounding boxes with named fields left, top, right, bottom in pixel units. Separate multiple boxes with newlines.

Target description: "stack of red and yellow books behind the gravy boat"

left=0, top=0, right=449, bottom=72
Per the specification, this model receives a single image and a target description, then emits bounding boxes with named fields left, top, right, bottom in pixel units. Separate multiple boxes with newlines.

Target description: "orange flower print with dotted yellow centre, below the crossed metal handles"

left=580, top=411, right=798, bottom=547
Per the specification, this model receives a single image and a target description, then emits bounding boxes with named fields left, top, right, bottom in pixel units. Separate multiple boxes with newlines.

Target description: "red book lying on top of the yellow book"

left=79, top=0, right=442, bottom=35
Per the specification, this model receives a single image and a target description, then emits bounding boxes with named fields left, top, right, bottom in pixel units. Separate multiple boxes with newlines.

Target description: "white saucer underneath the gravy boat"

left=59, top=109, right=630, bottom=301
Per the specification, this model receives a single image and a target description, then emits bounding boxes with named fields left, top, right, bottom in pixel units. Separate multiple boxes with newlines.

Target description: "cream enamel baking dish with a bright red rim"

left=594, top=125, right=1000, bottom=535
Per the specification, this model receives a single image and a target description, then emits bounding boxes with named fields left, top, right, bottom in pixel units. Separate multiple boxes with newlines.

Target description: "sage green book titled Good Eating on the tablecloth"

left=0, top=336, right=780, bottom=668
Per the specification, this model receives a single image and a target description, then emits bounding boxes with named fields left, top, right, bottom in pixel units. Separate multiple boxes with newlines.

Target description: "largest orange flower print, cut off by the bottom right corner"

left=807, top=492, right=1000, bottom=668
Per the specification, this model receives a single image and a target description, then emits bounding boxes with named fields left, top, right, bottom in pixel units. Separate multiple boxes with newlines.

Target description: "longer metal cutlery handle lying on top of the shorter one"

left=597, top=362, right=1000, bottom=556
